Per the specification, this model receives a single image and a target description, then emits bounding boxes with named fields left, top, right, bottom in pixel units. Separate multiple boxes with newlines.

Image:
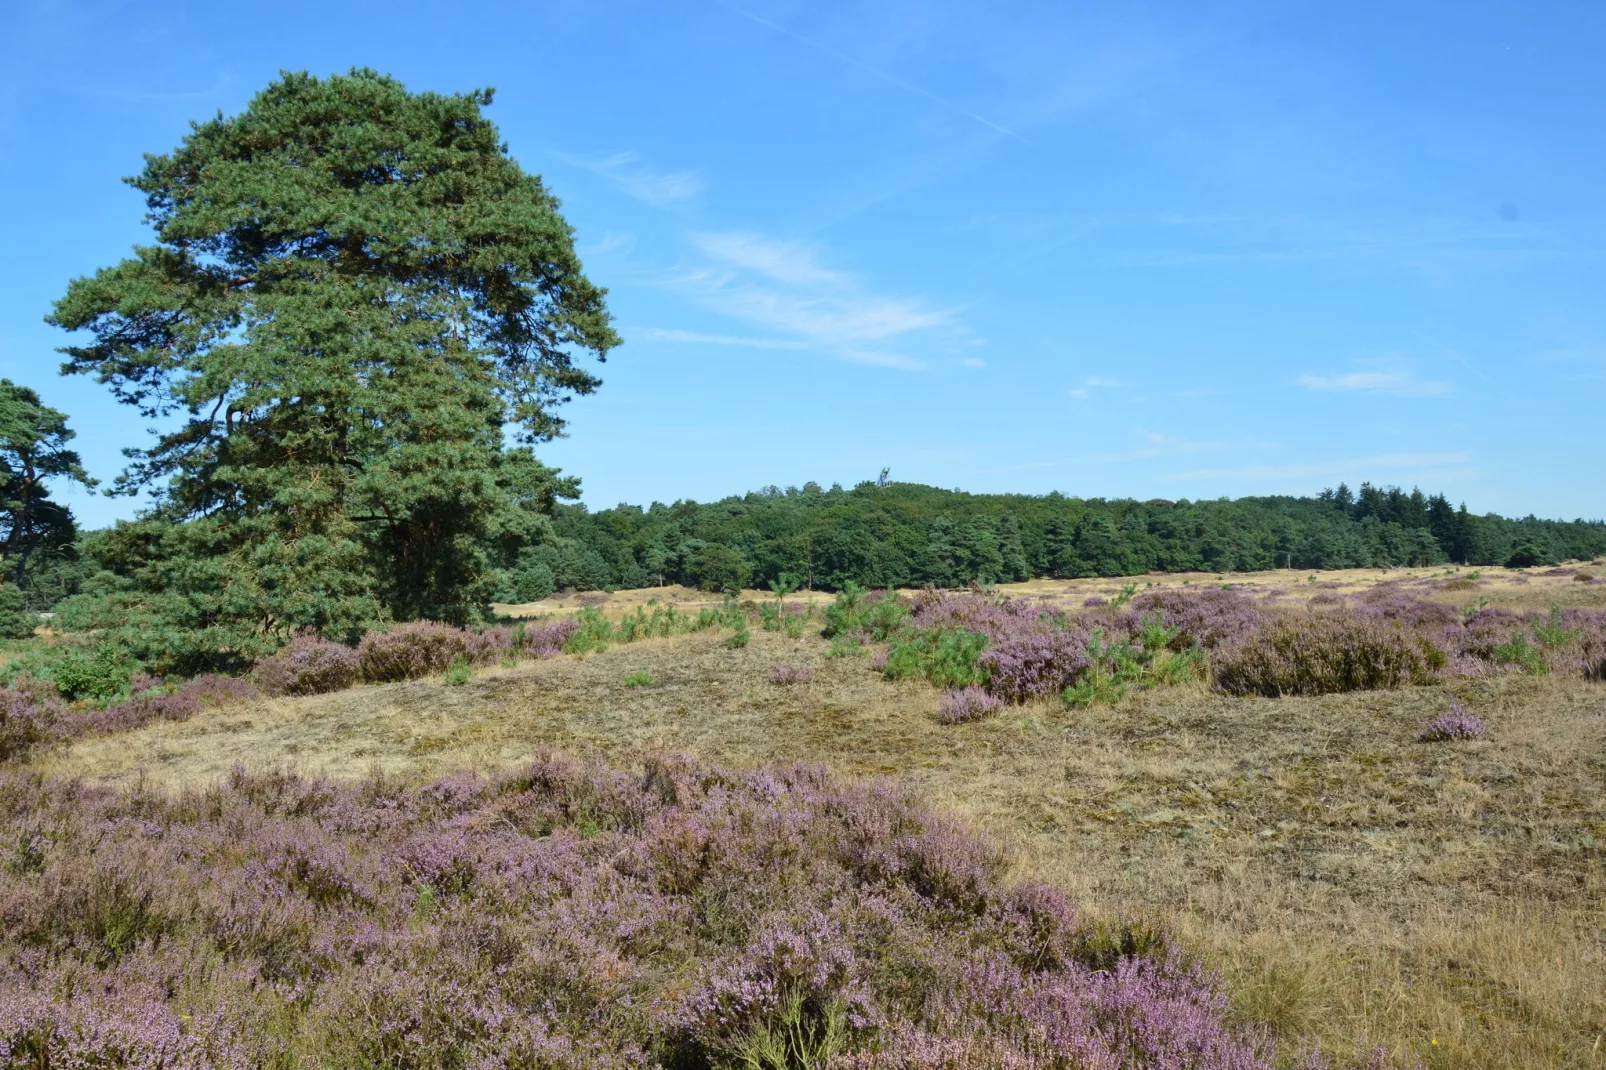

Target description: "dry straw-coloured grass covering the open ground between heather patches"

left=34, top=569, right=1606, bottom=1068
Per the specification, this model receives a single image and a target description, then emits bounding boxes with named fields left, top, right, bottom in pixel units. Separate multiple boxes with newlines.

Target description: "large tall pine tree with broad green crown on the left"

left=51, top=71, right=618, bottom=649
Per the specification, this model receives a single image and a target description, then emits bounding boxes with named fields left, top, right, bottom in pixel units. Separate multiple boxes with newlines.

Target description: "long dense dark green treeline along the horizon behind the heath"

left=495, top=482, right=1606, bottom=601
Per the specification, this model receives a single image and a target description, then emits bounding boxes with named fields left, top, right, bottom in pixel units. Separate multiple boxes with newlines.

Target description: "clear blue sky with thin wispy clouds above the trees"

left=0, top=0, right=1606, bottom=524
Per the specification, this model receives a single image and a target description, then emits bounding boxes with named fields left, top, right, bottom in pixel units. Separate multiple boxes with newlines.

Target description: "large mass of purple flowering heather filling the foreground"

left=0, top=753, right=1274, bottom=1070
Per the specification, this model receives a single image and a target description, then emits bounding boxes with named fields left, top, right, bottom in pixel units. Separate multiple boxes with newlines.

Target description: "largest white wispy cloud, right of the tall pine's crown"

left=663, top=231, right=954, bottom=371
